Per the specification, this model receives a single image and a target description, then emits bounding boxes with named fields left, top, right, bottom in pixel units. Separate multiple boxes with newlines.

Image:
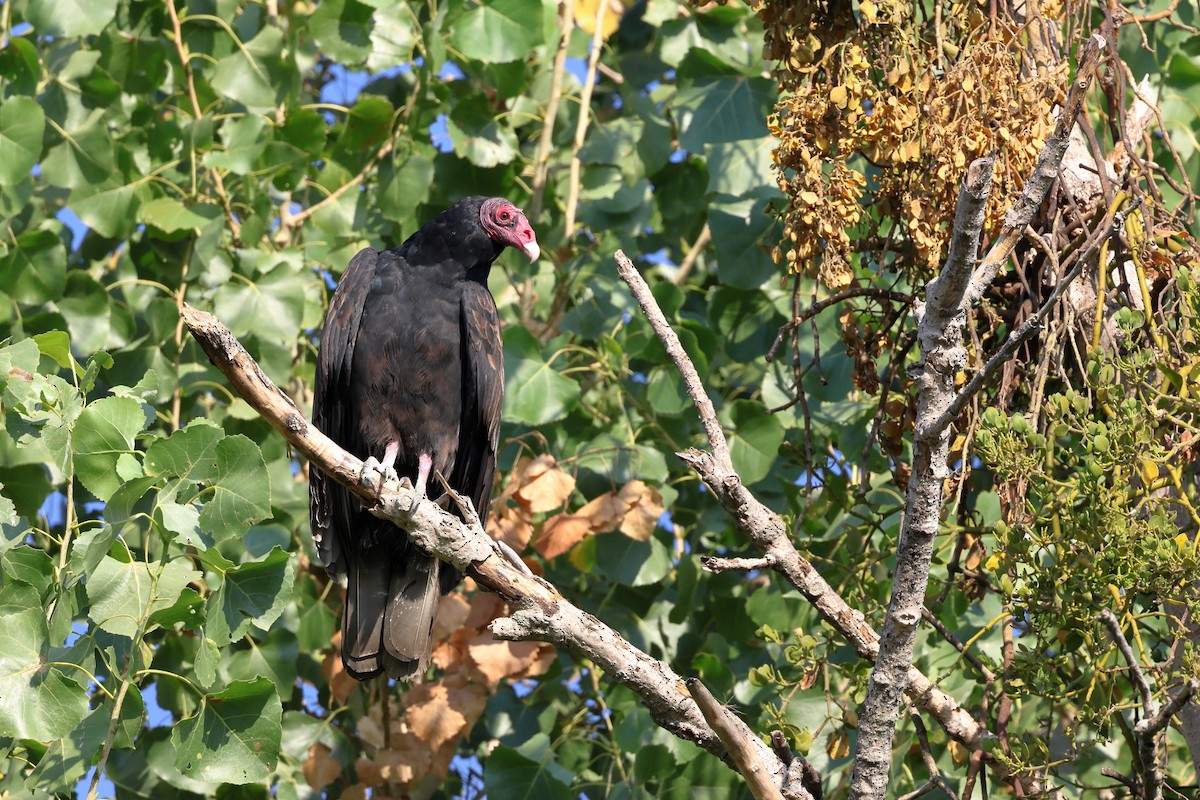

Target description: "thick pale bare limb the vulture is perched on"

left=180, top=303, right=787, bottom=784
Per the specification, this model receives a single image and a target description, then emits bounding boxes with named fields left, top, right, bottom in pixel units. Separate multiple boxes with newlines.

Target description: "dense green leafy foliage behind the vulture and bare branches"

left=0, top=0, right=1196, bottom=800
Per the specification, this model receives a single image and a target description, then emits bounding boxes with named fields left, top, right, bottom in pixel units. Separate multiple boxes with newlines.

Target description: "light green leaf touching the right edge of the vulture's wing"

left=504, top=325, right=580, bottom=426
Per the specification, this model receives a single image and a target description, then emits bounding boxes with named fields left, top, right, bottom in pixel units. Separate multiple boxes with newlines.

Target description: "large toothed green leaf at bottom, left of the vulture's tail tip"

left=170, top=678, right=283, bottom=786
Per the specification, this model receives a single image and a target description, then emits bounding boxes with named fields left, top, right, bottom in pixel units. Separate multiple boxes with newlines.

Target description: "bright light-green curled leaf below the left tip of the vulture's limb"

left=74, top=397, right=146, bottom=500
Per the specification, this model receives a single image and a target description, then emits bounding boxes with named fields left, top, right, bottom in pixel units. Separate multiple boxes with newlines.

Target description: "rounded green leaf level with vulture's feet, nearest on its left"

left=200, top=435, right=271, bottom=542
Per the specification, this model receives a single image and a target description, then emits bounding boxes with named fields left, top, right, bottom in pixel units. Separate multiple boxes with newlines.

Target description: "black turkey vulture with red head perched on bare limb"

left=308, top=197, right=539, bottom=680
